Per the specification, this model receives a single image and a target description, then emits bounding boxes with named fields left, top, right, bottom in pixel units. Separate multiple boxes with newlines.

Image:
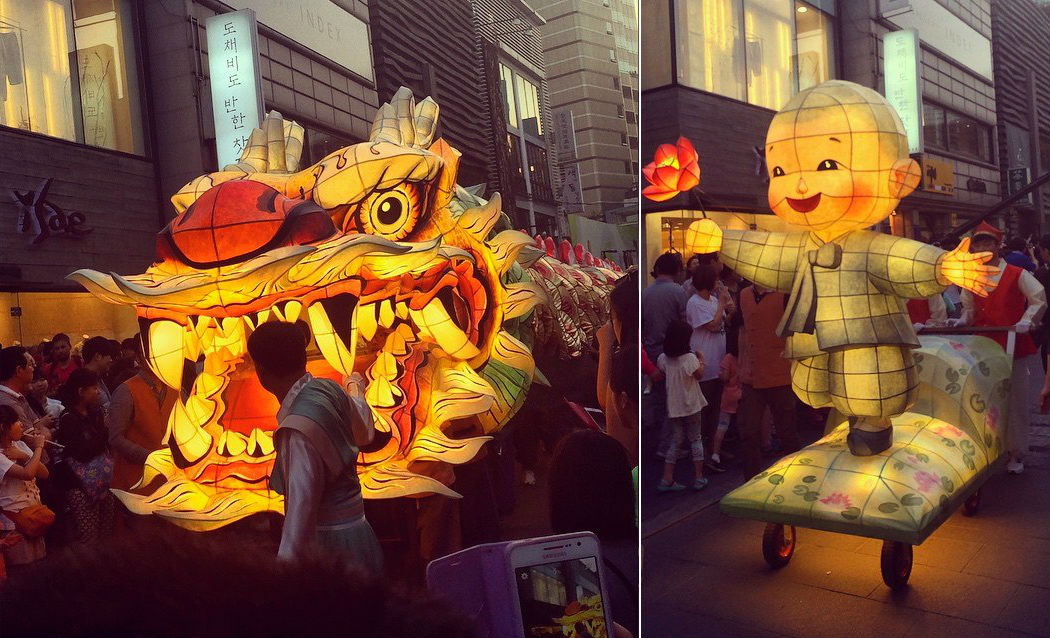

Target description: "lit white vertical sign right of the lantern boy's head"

left=882, top=28, right=922, bottom=153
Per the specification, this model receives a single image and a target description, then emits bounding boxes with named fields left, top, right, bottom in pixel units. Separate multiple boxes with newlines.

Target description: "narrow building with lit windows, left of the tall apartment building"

left=471, top=0, right=567, bottom=235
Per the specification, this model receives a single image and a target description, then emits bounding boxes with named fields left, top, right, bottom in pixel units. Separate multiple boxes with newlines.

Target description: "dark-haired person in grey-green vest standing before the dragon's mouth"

left=248, top=321, right=382, bottom=573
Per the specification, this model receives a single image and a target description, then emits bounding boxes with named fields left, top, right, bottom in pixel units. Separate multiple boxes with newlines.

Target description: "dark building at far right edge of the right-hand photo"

left=991, top=0, right=1050, bottom=237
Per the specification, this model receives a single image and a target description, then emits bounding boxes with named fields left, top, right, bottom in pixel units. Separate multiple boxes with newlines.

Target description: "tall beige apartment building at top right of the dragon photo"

left=533, top=0, right=639, bottom=221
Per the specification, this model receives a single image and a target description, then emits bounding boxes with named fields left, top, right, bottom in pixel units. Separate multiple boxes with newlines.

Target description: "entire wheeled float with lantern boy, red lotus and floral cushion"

left=646, top=81, right=1012, bottom=588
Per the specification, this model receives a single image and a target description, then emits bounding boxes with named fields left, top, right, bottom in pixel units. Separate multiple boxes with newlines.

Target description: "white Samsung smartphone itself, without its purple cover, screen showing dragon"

left=508, top=533, right=612, bottom=638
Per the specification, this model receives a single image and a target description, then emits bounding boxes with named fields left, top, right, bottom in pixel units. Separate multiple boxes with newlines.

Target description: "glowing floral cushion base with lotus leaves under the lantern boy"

left=720, top=336, right=1012, bottom=545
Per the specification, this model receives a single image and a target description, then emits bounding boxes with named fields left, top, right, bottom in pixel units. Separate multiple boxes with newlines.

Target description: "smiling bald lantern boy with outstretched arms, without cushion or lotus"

left=686, top=81, right=998, bottom=455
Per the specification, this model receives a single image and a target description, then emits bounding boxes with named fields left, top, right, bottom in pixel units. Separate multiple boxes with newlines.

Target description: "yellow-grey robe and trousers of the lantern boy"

left=721, top=230, right=948, bottom=417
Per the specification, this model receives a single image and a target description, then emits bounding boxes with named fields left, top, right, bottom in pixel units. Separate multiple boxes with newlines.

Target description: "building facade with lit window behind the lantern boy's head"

left=642, top=0, right=1002, bottom=281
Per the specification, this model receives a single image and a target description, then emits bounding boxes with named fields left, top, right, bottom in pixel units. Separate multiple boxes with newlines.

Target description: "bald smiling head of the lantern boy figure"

left=765, top=81, right=920, bottom=236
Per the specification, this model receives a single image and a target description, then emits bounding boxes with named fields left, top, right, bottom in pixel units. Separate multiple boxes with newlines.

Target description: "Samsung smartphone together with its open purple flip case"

left=426, top=532, right=612, bottom=638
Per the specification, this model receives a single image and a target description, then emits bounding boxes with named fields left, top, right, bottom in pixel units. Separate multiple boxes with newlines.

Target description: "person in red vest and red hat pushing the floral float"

left=949, top=221, right=1047, bottom=474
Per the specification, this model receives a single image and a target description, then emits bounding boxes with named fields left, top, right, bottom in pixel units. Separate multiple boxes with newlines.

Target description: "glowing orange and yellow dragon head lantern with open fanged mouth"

left=70, top=88, right=542, bottom=530
